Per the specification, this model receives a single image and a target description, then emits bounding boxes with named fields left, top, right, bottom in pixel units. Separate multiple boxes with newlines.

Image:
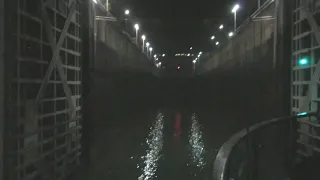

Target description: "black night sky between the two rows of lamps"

left=114, top=0, right=264, bottom=53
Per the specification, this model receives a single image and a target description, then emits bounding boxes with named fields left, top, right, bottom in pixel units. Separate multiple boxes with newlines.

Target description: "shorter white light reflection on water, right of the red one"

left=189, top=113, right=206, bottom=169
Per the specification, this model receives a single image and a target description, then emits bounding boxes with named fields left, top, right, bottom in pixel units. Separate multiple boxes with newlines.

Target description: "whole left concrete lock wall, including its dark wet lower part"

left=88, top=8, right=157, bottom=129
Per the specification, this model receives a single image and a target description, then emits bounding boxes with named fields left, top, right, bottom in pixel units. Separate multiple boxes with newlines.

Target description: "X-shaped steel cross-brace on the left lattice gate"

left=35, top=0, right=76, bottom=119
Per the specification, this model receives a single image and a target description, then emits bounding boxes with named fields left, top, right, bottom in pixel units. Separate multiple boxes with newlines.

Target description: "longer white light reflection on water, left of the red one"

left=137, top=112, right=164, bottom=180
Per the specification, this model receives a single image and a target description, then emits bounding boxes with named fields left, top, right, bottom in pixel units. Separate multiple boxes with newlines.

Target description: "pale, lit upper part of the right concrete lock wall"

left=200, top=3, right=275, bottom=73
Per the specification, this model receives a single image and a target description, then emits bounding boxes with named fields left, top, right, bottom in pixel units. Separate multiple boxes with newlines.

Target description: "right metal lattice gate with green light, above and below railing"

left=291, top=0, right=320, bottom=156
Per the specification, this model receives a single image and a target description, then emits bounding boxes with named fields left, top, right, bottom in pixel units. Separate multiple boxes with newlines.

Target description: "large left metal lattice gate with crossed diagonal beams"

left=0, top=0, right=82, bottom=180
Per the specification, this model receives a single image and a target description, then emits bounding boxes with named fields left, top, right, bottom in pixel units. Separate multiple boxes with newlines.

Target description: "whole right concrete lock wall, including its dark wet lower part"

left=199, top=1, right=291, bottom=119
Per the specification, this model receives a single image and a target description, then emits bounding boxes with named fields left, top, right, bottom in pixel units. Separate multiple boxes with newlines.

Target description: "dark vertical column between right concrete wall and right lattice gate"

left=274, top=0, right=292, bottom=116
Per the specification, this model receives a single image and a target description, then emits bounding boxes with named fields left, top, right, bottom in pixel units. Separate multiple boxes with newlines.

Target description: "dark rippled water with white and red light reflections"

left=81, top=105, right=246, bottom=180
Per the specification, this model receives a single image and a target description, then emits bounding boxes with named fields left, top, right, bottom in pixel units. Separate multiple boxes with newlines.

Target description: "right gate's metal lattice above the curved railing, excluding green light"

left=291, top=0, right=320, bottom=113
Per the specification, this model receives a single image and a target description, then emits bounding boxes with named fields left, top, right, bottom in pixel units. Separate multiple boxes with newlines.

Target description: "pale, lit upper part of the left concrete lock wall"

left=94, top=9, right=155, bottom=73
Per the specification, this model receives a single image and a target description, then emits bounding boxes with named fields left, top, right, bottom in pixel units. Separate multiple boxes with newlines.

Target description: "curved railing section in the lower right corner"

left=213, top=113, right=320, bottom=180
